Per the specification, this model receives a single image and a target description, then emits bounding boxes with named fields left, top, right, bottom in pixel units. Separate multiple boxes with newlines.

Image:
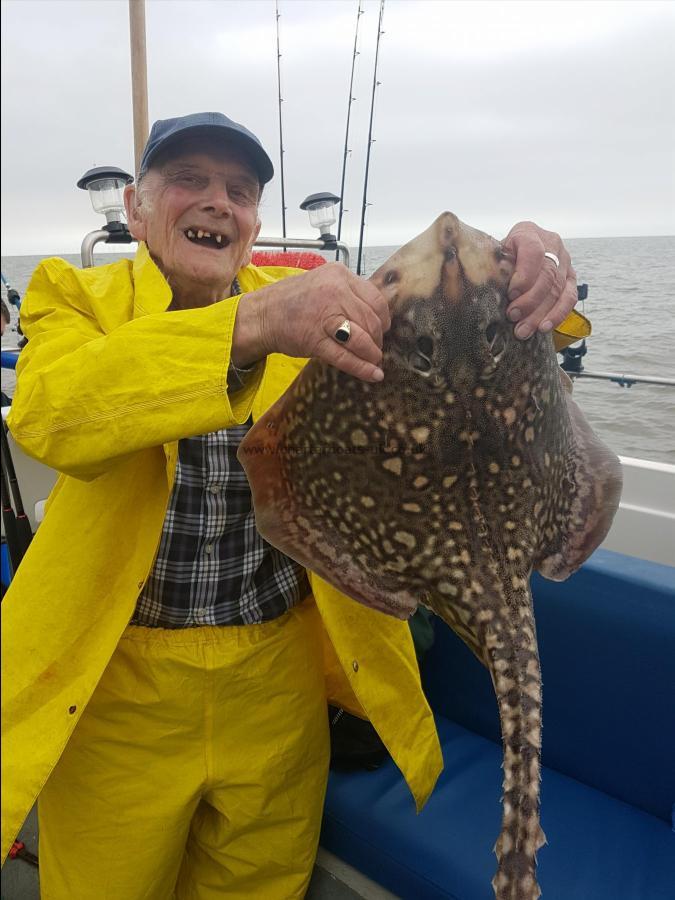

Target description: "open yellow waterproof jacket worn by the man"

left=2, top=245, right=443, bottom=860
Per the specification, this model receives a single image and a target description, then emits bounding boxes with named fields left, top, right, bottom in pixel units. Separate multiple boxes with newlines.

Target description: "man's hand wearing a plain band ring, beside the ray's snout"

left=503, top=222, right=577, bottom=339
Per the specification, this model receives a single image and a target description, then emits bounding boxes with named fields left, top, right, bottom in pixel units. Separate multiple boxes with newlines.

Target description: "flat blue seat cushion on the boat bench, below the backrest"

left=321, top=718, right=675, bottom=900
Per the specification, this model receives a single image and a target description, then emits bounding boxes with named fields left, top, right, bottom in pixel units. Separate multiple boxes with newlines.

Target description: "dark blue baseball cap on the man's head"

left=139, top=113, right=274, bottom=185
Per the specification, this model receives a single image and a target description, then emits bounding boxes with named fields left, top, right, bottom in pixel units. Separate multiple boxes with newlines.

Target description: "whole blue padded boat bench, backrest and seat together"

left=321, top=550, right=675, bottom=900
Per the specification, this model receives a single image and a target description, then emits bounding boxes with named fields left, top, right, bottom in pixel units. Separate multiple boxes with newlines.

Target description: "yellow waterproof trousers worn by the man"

left=38, top=601, right=329, bottom=900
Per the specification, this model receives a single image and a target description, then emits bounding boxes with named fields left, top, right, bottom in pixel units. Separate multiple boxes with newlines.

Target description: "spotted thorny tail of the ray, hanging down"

left=488, top=597, right=546, bottom=900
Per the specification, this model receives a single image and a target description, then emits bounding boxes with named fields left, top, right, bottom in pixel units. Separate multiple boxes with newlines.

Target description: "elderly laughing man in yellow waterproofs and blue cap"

left=3, top=113, right=576, bottom=900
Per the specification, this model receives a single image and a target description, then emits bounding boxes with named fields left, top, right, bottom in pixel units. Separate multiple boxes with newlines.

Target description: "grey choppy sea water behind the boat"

left=2, top=237, right=675, bottom=463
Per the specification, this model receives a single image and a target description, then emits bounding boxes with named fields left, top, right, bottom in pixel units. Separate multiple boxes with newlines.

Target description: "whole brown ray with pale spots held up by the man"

left=239, top=213, right=621, bottom=900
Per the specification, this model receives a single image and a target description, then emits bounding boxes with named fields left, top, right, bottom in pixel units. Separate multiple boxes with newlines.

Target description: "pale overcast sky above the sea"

left=0, top=0, right=675, bottom=255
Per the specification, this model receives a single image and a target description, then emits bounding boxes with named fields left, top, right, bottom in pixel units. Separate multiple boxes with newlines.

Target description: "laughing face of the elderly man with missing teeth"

left=125, top=147, right=260, bottom=291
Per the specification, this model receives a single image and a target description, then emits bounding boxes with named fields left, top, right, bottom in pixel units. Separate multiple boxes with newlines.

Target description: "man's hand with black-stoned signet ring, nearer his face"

left=232, top=263, right=391, bottom=381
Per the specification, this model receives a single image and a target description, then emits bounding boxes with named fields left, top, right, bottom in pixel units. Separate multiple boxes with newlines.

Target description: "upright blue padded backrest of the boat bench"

left=424, top=550, right=675, bottom=824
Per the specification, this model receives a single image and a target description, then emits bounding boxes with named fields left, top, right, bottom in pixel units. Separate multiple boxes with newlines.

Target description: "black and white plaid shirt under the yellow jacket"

left=131, top=287, right=309, bottom=628
